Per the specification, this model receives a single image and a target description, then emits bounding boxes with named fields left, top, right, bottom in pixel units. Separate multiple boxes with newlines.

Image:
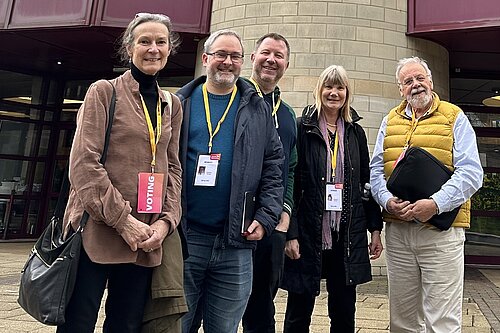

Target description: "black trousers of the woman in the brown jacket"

left=56, top=248, right=153, bottom=333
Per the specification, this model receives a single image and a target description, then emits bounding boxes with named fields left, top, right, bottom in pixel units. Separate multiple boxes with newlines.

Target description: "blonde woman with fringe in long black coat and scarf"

left=282, top=65, right=383, bottom=333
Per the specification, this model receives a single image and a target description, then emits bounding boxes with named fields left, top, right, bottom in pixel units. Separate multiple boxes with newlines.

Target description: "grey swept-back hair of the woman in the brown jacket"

left=118, top=13, right=180, bottom=63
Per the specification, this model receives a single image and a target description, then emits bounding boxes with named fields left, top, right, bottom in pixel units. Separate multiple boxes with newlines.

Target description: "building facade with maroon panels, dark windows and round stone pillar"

left=0, top=0, right=500, bottom=260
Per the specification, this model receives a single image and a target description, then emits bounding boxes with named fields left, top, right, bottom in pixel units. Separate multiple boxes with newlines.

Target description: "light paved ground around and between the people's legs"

left=0, top=242, right=500, bottom=333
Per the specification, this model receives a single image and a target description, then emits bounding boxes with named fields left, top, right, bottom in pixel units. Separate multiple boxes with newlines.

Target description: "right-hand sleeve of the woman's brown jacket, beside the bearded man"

left=159, top=96, right=183, bottom=234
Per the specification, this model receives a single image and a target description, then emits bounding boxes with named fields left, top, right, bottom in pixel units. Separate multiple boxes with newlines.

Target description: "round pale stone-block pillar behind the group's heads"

left=207, top=0, right=449, bottom=151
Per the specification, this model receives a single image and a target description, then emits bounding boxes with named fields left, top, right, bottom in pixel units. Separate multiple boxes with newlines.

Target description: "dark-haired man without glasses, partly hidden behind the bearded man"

left=243, top=33, right=297, bottom=333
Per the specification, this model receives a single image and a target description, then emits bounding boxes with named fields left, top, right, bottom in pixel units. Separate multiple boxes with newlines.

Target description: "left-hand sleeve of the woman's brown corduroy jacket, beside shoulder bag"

left=69, top=81, right=132, bottom=232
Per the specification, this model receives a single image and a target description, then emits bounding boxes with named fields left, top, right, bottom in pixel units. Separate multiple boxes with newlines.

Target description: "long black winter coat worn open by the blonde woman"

left=281, top=106, right=383, bottom=295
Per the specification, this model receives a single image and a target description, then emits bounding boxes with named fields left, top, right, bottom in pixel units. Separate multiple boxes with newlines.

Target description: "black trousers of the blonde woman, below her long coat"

left=283, top=234, right=356, bottom=333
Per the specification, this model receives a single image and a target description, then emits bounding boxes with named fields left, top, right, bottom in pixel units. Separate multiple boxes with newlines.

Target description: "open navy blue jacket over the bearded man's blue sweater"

left=176, top=76, right=283, bottom=248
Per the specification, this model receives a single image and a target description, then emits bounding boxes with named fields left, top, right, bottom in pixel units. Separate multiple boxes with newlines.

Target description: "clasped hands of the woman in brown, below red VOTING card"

left=120, top=214, right=169, bottom=252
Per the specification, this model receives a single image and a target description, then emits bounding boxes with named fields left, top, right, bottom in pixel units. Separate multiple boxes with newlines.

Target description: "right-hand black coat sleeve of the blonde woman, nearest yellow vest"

left=355, top=124, right=384, bottom=232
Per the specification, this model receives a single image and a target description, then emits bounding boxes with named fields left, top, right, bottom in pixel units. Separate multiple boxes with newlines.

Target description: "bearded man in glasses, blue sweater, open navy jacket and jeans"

left=177, top=30, right=283, bottom=333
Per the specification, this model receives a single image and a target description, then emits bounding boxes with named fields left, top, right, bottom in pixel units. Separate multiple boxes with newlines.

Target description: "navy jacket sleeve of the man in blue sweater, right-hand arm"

left=254, top=99, right=284, bottom=236
